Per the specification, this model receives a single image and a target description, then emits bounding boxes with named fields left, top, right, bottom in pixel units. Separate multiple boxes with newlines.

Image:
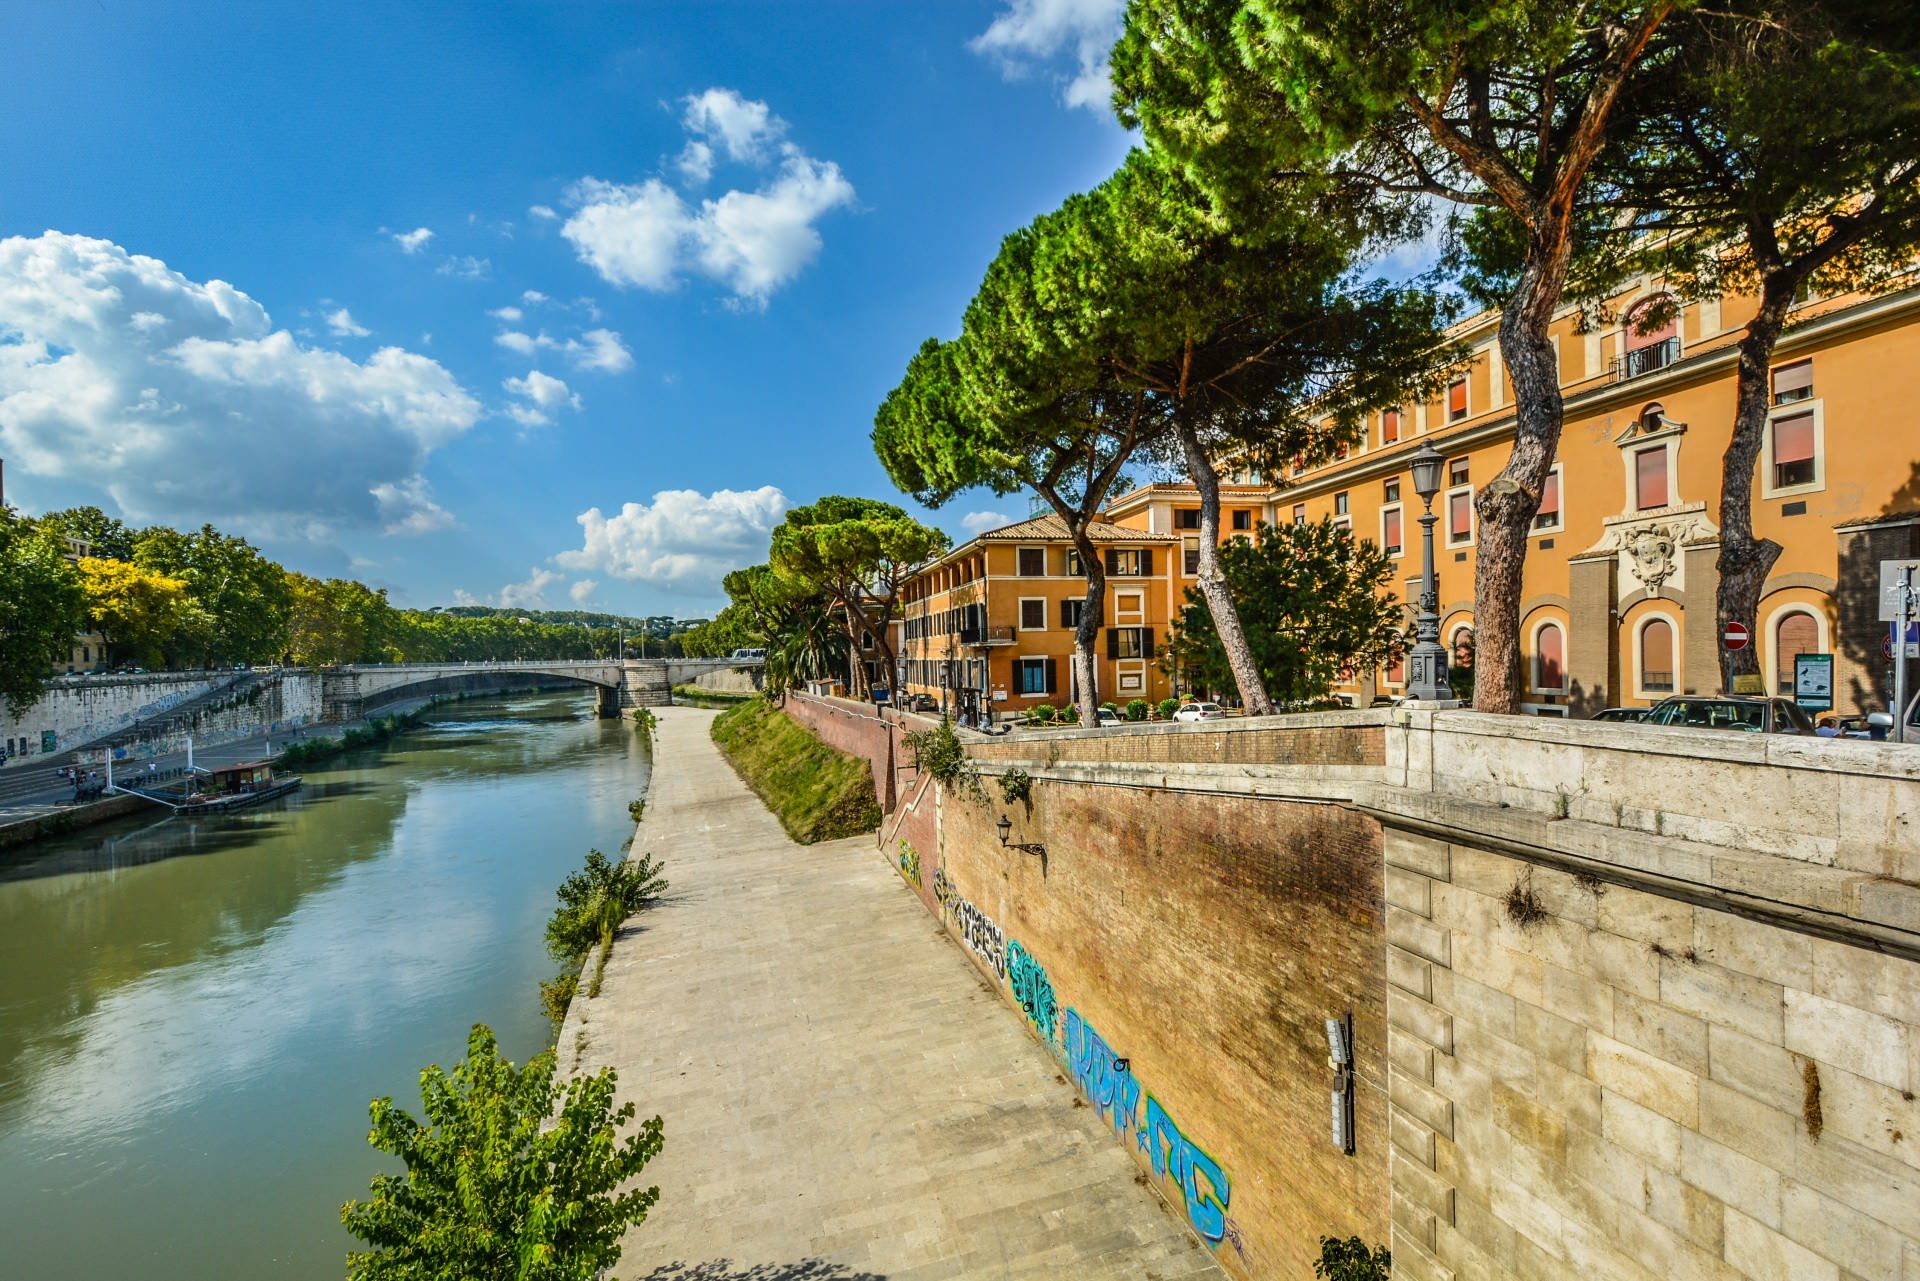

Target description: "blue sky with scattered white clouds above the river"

left=0, top=0, right=1129, bottom=616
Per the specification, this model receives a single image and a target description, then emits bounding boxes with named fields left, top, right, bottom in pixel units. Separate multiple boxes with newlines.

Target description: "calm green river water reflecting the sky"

left=0, top=695, right=648, bottom=1281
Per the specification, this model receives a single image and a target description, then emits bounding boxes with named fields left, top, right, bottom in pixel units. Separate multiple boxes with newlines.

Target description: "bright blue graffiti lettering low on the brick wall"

left=1059, top=1014, right=1246, bottom=1256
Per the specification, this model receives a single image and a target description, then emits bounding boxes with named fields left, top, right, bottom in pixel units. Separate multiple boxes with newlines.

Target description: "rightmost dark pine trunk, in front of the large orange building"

left=1715, top=273, right=1799, bottom=693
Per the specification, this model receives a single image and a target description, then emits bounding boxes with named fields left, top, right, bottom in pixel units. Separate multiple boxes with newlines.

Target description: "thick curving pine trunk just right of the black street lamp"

left=1473, top=245, right=1569, bottom=714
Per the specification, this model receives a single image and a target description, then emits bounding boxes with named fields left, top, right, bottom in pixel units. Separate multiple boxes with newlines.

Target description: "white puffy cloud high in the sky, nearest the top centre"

left=561, top=88, right=854, bottom=305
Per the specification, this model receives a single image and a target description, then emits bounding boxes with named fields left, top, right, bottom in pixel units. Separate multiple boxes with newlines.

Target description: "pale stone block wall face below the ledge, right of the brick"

left=1384, top=830, right=1920, bottom=1281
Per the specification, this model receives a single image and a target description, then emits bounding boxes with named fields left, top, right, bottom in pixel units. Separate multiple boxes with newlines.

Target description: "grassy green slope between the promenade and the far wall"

left=714, top=699, right=879, bottom=845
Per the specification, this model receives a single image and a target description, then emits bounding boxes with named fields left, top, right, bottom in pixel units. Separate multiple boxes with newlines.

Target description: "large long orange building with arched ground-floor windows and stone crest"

left=1106, top=278, right=1920, bottom=716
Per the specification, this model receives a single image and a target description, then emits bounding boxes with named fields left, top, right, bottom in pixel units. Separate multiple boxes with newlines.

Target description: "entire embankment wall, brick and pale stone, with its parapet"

left=814, top=713, right=1920, bottom=1281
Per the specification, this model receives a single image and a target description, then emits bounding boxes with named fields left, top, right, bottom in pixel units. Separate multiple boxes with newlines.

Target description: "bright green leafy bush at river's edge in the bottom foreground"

left=340, top=1024, right=664, bottom=1281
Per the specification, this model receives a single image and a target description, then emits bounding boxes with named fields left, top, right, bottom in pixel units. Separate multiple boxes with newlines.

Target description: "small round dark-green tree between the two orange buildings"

left=1179, top=520, right=1405, bottom=703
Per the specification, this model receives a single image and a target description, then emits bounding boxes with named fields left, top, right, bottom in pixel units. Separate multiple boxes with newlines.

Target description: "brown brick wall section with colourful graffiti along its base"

left=922, top=782, right=1388, bottom=1277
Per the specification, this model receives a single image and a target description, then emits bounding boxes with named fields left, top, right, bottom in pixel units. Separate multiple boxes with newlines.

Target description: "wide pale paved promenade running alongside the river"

left=561, top=707, right=1223, bottom=1281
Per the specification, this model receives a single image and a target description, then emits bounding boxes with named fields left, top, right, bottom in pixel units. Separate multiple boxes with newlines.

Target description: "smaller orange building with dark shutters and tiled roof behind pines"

left=900, top=515, right=1179, bottom=718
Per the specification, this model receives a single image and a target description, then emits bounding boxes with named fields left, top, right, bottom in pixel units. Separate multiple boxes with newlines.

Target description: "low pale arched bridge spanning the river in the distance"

left=321, top=659, right=760, bottom=720
